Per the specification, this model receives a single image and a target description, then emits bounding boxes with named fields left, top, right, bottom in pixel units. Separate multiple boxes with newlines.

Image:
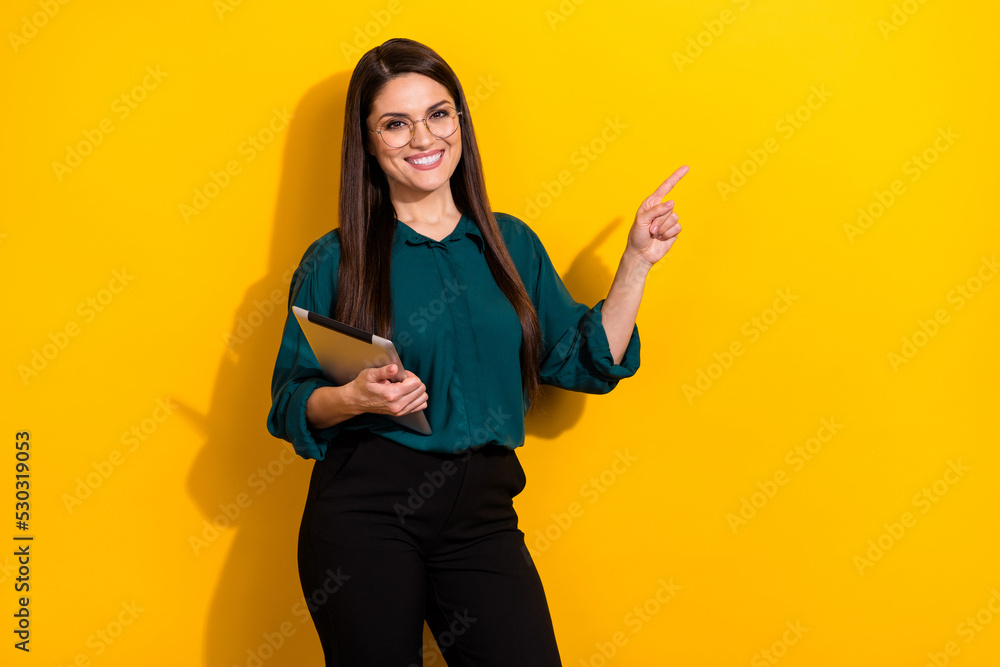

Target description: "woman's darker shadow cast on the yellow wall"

left=181, top=71, right=617, bottom=667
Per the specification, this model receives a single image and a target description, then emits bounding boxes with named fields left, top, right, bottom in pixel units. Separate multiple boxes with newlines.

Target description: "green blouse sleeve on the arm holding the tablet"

left=267, top=235, right=343, bottom=459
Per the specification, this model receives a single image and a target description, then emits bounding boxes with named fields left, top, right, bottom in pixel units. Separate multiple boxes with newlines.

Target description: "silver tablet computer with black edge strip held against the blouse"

left=292, top=306, right=431, bottom=435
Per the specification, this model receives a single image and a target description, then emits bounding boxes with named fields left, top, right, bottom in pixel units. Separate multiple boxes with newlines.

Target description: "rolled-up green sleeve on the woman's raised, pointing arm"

left=522, top=223, right=639, bottom=394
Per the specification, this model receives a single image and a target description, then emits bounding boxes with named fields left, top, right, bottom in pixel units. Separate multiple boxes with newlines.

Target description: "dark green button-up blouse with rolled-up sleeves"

left=267, top=213, right=639, bottom=459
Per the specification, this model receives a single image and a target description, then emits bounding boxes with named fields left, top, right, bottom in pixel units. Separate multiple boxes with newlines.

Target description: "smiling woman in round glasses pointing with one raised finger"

left=268, top=39, right=687, bottom=667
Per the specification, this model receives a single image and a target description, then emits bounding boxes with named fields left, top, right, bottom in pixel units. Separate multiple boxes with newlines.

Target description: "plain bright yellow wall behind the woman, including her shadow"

left=0, top=0, right=1000, bottom=667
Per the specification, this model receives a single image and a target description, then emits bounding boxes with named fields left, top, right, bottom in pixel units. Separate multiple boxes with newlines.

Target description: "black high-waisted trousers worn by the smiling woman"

left=298, top=433, right=562, bottom=667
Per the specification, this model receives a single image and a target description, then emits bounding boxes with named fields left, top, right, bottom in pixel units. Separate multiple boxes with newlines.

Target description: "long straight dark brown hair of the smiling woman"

left=334, top=38, right=541, bottom=408
